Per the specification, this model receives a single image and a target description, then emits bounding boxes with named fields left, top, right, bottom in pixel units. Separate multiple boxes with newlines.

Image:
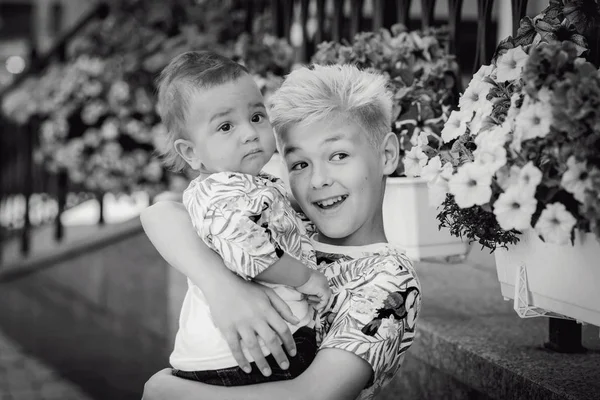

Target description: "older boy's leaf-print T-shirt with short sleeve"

left=313, top=241, right=421, bottom=400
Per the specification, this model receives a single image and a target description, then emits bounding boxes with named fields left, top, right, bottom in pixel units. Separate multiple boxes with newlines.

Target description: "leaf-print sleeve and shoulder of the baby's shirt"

left=183, top=172, right=316, bottom=279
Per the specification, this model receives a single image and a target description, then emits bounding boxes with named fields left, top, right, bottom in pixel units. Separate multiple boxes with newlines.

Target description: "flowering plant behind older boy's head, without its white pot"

left=312, top=24, right=458, bottom=176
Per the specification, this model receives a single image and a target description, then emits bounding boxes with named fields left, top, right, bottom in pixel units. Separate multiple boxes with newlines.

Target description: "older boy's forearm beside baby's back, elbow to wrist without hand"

left=140, top=202, right=239, bottom=293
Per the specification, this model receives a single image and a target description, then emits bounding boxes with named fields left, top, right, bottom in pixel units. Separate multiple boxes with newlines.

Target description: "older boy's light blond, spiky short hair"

left=269, top=64, right=392, bottom=146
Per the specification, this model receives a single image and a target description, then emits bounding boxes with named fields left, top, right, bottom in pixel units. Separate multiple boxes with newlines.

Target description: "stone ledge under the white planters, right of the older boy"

left=399, top=252, right=600, bottom=400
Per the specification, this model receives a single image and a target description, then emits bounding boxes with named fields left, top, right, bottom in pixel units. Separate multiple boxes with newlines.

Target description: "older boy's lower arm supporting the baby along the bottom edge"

left=143, top=349, right=373, bottom=400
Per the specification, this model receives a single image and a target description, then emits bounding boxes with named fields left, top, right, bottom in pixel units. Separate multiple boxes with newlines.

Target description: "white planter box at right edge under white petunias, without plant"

left=494, top=231, right=600, bottom=326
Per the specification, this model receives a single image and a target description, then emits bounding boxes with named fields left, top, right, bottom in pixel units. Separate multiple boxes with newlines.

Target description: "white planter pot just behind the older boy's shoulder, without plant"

left=383, top=178, right=469, bottom=261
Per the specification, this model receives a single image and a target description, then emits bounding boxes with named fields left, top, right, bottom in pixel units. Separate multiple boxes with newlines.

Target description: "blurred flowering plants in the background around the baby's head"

left=3, top=0, right=293, bottom=193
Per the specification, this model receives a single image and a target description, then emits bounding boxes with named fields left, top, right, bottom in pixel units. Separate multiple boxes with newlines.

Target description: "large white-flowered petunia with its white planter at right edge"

left=417, top=1, right=600, bottom=326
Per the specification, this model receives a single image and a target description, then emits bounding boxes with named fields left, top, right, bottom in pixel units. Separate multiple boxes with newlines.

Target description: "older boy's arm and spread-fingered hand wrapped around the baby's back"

left=140, top=202, right=298, bottom=371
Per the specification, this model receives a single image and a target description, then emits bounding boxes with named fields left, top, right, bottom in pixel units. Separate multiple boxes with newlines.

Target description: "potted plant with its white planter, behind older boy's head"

left=312, top=25, right=468, bottom=260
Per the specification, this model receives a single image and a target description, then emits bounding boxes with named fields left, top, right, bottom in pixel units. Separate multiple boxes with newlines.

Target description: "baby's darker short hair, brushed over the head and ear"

left=155, top=51, right=248, bottom=171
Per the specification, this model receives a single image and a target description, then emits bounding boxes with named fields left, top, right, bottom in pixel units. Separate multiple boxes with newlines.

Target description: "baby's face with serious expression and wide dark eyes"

left=186, top=74, right=275, bottom=175
